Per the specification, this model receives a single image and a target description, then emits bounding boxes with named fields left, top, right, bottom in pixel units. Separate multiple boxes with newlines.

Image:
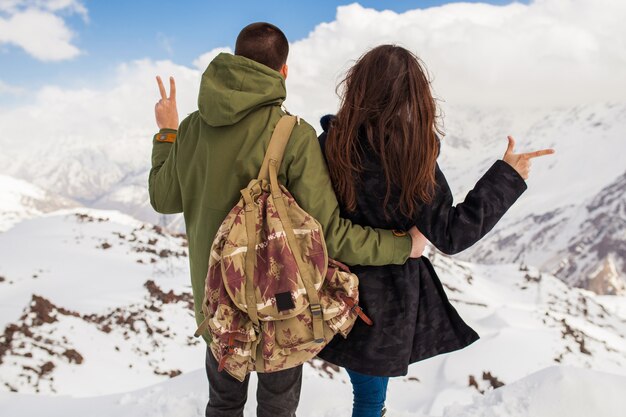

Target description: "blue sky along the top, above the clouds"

left=0, top=0, right=527, bottom=91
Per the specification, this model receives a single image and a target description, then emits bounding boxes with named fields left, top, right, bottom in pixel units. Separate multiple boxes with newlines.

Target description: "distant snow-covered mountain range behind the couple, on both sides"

left=0, top=103, right=626, bottom=293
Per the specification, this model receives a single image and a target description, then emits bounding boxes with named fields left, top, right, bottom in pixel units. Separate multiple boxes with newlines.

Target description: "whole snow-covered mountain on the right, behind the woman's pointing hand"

left=441, top=104, right=626, bottom=294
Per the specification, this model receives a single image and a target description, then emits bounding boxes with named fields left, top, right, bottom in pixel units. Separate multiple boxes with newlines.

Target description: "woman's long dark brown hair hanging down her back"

left=325, top=45, right=441, bottom=217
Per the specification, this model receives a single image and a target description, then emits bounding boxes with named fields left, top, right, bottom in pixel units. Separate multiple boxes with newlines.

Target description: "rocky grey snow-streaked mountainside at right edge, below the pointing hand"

left=466, top=168, right=626, bottom=294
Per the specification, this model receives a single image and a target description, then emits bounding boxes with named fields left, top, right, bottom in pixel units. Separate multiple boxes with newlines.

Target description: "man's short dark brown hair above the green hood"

left=235, top=22, right=289, bottom=71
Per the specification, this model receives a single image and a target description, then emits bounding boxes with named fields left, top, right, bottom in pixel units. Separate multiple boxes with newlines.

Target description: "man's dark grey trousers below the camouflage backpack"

left=206, top=349, right=302, bottom=417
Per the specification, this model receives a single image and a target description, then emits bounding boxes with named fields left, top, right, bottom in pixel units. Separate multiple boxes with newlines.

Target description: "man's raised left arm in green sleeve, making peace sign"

left=148, top=77, right=183, bottom=214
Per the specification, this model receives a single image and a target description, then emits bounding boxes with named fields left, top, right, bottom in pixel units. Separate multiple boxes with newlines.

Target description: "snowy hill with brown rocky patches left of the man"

left=0, top=209, right=202, bottom=395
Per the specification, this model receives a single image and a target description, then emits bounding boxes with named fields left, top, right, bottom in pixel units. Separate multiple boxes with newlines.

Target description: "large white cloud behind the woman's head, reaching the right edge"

left=287, top=0, right=626, bottom=118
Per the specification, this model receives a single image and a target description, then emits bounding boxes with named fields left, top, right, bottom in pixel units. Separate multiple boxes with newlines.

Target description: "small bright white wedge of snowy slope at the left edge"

left=0, top=175, right=78, bottom=232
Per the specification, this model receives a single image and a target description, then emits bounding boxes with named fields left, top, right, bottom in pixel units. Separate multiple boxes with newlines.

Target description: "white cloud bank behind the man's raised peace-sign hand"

left=0, top=59, right=200, bottom=151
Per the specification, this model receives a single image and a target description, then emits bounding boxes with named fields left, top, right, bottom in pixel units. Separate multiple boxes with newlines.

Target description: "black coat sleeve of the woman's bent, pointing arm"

left=415, top=160, right=527, bottom=254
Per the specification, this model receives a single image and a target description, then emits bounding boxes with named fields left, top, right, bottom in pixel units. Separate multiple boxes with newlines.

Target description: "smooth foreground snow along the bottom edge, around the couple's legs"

left=0, top=358, right=626, bottom=417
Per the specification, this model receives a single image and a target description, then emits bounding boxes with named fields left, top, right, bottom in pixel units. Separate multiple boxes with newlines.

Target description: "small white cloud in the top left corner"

left=0, top=0, right=87, bottom=61
